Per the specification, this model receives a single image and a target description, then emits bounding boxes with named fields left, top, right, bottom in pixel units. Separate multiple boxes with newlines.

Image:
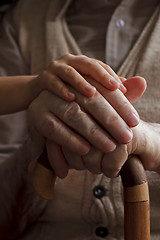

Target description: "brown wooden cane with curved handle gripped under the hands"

left=33, top=150, right=150, bottom=240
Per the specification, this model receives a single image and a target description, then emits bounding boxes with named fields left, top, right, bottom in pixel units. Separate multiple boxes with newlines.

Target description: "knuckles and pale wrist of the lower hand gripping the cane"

left=63, top=121, right=160, bottom=178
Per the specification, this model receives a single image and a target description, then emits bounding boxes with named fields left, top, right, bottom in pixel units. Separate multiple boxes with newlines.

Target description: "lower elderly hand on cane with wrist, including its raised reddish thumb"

left=55, top=77, right=149, bottom=177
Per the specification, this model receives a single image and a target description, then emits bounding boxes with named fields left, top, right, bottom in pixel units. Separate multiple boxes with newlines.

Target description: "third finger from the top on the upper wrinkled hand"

left=43, top=93, right=116, bottom=152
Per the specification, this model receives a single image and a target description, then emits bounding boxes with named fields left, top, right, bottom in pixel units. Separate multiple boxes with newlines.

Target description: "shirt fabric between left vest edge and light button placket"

left=64, top=0, right=120, bottom=62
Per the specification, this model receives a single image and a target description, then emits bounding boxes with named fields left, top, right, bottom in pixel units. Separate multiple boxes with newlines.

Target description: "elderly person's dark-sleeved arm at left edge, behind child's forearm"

left=0, top=8, right=46, bottom=240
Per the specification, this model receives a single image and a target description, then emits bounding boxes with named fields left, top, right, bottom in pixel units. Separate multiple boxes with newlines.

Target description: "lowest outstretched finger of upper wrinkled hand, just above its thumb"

left=29, top=91, right=90, bottom=155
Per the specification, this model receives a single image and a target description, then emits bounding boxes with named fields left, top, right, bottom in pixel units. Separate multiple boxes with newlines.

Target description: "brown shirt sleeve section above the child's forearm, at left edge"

left=0, top=10, right=29, bottom=76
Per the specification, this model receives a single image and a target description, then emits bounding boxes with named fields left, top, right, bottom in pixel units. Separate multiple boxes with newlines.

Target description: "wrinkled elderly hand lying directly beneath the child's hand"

left=29, top=73, right=146, bottom=177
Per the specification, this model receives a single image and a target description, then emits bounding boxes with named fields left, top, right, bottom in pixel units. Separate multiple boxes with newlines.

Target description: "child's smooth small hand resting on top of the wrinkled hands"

left=37, top=54, right=126, bottom=101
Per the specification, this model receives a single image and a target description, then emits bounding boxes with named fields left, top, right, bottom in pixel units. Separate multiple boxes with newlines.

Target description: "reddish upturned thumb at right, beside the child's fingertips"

left=123, top=76, right=147, bottom=103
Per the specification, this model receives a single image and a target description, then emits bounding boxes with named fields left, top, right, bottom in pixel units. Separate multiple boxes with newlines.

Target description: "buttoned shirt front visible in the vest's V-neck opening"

left=66, top=0, right=159, bottom=71
